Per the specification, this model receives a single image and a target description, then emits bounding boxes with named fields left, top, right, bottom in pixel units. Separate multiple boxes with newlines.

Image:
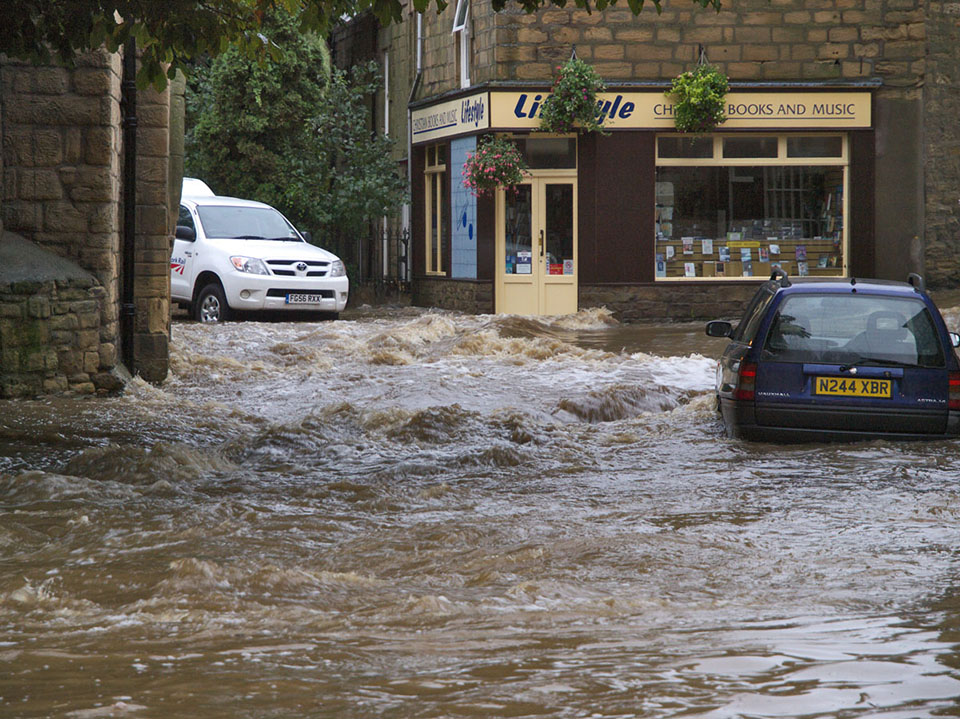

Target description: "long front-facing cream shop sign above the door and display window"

left=490, top=90, right=872, bottom=130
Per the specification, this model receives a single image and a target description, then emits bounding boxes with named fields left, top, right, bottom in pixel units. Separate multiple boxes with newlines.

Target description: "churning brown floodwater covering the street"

left=0, top=307, right=960, bottom=719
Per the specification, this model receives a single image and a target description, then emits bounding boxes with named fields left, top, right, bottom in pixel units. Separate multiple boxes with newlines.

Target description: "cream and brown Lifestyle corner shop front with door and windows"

left=412, top=88, right=875, bottom=319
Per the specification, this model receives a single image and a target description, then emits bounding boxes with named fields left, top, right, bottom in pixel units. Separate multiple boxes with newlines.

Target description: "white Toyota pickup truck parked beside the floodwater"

left=170, top=178, right=350, bottom=322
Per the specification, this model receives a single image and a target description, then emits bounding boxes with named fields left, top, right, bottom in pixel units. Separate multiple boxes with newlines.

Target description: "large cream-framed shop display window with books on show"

left=654, top=133, right=849, bottom=280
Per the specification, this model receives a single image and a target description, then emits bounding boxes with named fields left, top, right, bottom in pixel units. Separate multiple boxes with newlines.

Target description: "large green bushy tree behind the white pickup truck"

left=186, top=16, right=406, bottom=250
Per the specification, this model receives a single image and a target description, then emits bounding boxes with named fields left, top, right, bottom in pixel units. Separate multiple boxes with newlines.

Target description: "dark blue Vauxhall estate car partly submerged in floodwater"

left=706, top=270, right=960, bottom=442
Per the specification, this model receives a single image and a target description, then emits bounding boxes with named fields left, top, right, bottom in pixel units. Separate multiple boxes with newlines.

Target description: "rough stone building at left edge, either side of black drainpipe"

left=0, top=51, right=182, bottom=397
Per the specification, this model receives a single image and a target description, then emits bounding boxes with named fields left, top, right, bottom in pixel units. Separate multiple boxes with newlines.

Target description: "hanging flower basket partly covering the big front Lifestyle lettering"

left=540, top=56, right=606, bottom=133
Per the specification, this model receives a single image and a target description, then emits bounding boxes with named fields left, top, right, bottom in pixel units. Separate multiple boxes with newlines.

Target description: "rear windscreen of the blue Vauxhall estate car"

left=763, top=294, right=945, bottom=367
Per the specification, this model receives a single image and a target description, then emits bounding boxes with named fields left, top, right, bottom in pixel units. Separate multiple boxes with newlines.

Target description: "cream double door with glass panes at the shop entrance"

left=496, top=177, right=577, bottom=315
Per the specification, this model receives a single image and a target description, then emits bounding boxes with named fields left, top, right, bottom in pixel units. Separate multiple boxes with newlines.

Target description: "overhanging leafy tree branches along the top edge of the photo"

left=0, top=0, right=721, bottom=89
